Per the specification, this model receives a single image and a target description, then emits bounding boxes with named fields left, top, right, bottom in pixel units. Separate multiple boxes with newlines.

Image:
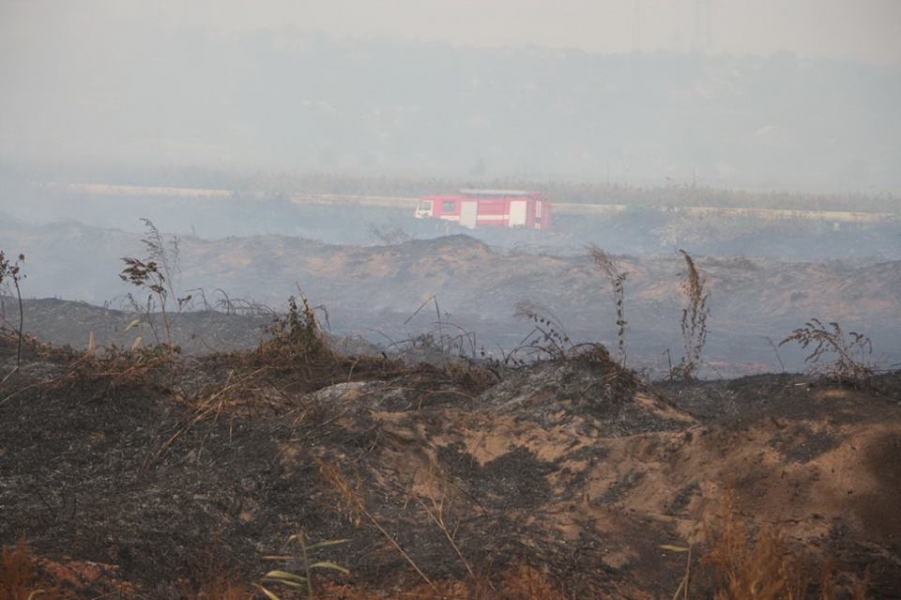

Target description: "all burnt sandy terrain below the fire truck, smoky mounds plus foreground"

left=0, top=197, right=901, bottom=600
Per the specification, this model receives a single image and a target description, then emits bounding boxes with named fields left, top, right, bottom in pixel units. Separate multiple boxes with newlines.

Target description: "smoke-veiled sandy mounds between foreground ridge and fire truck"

left=0, top=223, right=901, bottom=377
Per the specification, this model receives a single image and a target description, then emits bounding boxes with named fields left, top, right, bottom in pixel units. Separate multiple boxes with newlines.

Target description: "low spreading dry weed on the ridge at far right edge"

left=779, top=319, right=873, bottom=387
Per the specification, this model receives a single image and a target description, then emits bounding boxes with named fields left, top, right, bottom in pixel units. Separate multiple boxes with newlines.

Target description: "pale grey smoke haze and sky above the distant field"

left=0, top=0, right=901, bottom=192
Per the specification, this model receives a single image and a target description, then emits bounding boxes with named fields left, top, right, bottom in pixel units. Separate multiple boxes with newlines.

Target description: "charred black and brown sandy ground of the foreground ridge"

left=0, top=324, right=901, bottom=598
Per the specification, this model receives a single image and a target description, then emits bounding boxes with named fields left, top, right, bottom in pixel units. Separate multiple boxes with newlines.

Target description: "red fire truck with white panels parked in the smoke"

left=416, top=190, right=551, bottom=229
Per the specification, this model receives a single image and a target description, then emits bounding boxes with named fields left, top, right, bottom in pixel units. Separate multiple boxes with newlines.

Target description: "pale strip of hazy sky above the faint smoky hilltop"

left=0, top=0, right=901, bottom=62
